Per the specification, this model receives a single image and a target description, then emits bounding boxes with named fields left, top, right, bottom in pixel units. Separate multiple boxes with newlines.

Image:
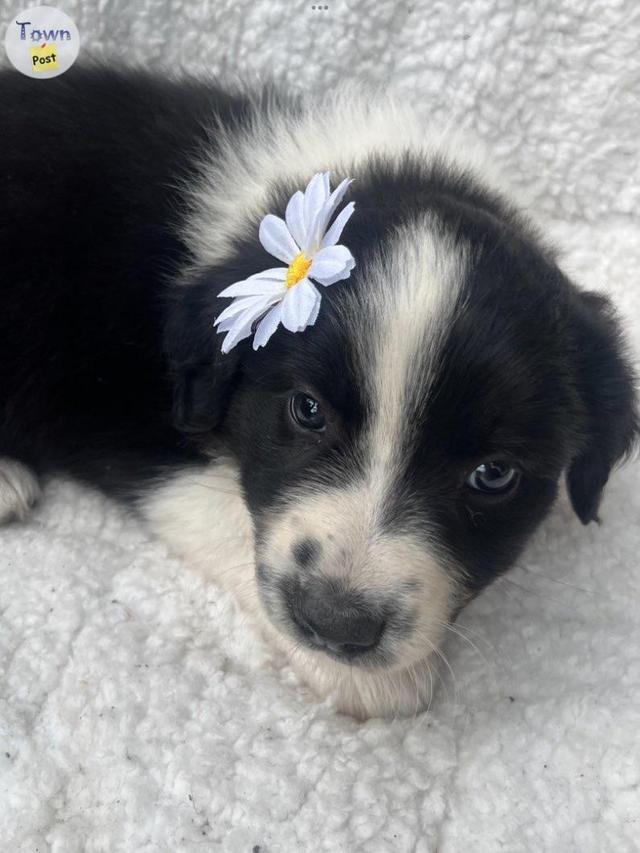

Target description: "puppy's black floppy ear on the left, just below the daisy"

left=164, top=276, right=241, bottom=436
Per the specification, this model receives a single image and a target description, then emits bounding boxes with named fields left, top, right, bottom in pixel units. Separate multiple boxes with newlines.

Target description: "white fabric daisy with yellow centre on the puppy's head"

left=214, top=172, right=356, bottom=353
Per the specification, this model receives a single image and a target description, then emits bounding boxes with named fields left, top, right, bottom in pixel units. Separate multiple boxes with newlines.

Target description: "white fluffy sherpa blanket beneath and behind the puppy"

left=0, top=0, right=640, bottom=853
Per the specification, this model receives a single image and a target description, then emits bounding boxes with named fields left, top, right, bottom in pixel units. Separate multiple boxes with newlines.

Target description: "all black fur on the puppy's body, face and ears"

left=0, top=63, right=637, bottom=624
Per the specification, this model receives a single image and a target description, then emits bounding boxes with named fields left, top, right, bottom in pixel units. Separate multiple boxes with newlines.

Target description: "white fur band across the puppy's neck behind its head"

left=183, top=84, right=505, bottom=266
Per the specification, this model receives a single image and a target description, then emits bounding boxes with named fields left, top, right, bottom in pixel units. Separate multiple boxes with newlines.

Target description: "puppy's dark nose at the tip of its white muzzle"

left=290, top=590, right=384, bottom=658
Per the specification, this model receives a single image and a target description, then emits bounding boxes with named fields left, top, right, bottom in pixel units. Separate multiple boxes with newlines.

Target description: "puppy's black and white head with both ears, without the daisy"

left=168, top=158, right=637, bottom=712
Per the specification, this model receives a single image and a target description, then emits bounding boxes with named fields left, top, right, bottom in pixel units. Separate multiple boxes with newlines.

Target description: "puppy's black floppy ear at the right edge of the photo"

left=567, top=290, right=639, bottom=524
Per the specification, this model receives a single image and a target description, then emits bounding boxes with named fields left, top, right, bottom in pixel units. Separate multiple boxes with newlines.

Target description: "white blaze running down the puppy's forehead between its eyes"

left=352, top=215, right=469, bottom=503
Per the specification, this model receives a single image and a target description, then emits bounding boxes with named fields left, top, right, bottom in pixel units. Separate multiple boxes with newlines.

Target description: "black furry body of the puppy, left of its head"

left=0, top=68, right=255, bottom=491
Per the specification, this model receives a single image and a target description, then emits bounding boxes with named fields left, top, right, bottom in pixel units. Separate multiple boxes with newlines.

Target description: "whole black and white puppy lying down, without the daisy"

left=0, top=67, right=638, bottom=717
